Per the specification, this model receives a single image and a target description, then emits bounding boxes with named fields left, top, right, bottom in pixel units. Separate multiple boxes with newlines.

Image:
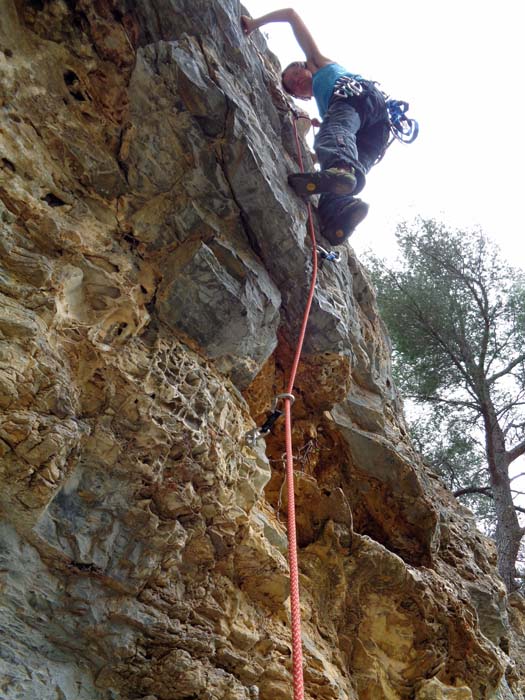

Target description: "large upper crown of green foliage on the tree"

left=369, top=220, right=525, bottom=421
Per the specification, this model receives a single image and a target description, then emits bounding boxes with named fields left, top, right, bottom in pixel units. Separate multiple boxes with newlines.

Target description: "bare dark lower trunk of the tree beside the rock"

left=483, top=401, right=523, bottom=593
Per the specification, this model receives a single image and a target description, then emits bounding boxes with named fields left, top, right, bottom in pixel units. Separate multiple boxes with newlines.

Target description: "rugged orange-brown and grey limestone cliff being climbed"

left=0, top=0, right=525, bottom=700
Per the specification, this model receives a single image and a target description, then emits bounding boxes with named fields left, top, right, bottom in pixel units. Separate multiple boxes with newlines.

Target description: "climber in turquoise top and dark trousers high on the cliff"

left=241, top=8, right=389, bottom=245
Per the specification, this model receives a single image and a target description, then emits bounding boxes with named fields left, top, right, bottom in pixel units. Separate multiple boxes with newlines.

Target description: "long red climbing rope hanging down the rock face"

left=284, top=115, right=317, bottom=700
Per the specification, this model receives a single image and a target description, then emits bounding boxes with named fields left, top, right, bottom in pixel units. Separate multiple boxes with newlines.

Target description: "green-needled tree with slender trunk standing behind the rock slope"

left=369, top=219, right=525, bottom=591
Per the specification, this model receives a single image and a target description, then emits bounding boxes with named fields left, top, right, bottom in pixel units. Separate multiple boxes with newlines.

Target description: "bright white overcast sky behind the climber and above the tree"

left=244, top=0, right=525, bottom=519
